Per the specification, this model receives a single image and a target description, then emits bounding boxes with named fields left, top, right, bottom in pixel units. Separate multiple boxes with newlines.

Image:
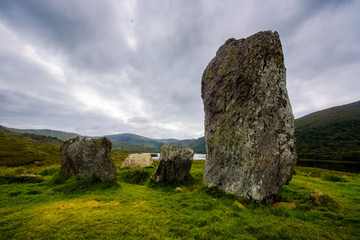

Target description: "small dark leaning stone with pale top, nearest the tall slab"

left=151, top=145, right=194, bottom=182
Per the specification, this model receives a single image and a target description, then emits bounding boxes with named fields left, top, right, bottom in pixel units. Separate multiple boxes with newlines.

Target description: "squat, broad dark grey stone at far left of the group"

left=61, top=136, right=116, bottom=181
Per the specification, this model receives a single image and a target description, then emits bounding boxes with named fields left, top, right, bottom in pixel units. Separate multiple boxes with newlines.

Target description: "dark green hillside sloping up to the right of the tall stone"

left=295, top=101, right=360, bottom=161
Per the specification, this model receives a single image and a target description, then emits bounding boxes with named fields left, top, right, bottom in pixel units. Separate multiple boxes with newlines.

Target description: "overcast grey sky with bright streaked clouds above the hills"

left=0, top=0, right=360, bottom=139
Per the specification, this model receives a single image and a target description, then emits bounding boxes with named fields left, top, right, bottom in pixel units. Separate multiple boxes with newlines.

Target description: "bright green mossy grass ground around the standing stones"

left=0, top=157, right=360, bottom=239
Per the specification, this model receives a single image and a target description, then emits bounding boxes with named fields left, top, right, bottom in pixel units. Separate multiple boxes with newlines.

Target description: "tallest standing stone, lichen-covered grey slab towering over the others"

left=201, top=31, right=296, bottom=201
